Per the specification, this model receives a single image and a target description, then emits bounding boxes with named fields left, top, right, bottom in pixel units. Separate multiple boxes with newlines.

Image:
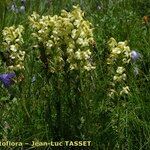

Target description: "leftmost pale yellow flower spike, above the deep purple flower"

left=2, top=25, right=25, bottom=70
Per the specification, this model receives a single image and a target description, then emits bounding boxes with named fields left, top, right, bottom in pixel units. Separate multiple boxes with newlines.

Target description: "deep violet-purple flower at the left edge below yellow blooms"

left=0, top=73, right=16, bottom=87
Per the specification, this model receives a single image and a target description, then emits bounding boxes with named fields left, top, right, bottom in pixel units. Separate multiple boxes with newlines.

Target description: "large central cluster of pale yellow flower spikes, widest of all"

left=29, top=6, right=95, bottom=72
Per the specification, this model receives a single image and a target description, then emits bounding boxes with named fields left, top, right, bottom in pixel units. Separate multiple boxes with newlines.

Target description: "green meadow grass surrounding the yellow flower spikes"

left=0, top=0, right=150, bottom=150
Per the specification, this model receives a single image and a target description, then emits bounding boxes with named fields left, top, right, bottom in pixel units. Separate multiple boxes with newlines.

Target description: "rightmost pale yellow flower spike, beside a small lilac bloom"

left=107, top=38, right=131, bottom=98
